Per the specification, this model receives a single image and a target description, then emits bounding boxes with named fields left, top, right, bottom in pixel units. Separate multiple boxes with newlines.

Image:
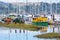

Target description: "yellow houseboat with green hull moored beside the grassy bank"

left=32, top=17, right=48, bottom=26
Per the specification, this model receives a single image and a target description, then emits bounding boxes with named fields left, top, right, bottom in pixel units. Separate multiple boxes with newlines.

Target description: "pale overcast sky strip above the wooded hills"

left=0, top=0, right=60, bottom=3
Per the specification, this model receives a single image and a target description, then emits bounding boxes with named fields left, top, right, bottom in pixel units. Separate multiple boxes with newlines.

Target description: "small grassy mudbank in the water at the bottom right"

left=34, top=33, right=60, bottom=38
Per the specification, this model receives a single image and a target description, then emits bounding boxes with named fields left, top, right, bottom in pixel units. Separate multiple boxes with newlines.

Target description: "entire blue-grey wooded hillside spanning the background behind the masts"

left=0, top=1, right=60, bottom=14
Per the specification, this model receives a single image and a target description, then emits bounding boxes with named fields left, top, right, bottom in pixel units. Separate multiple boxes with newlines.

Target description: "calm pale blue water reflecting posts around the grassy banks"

left=0, top=25, right=60, bottom=40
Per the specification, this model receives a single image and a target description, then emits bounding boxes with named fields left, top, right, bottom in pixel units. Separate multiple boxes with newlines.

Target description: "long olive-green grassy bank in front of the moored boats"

left=0, top=23, right=42, bottom=31
